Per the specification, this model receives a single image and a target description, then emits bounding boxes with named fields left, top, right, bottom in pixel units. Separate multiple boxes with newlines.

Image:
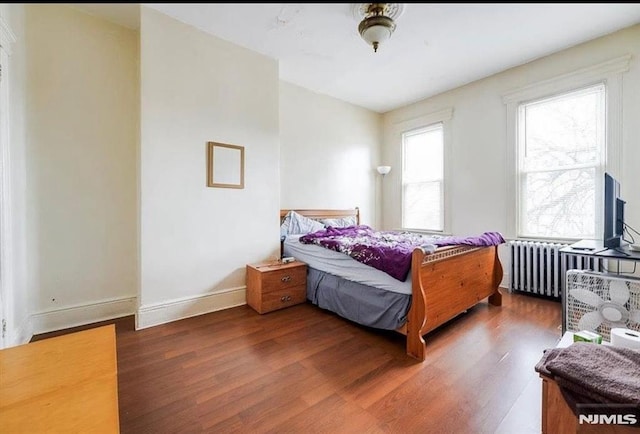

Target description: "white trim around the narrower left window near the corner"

left=394, top=108, right=453, bottom=235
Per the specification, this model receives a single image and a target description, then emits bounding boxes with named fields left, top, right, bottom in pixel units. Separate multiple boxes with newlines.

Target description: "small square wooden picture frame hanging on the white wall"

left=207, top=142, right=244, bottom=189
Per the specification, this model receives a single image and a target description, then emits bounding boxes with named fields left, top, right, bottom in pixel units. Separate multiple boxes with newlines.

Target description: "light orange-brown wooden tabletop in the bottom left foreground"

left=0, top=325, right=120, bottom=433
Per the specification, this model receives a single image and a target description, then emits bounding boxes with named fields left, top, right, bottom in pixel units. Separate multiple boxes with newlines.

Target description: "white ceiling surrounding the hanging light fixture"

left=73, top=3, right=640, bottom=113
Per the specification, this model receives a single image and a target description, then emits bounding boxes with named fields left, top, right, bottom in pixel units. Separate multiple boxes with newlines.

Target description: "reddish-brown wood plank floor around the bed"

left=34, top=291, right=561, bottom=434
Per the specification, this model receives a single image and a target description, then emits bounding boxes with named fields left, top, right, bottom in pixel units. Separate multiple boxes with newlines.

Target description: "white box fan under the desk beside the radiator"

left=565, top=270, right=640, bottom=341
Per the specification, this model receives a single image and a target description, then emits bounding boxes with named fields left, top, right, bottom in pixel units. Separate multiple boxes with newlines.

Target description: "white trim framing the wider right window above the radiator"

left=502, top=54, right=631, bottom=240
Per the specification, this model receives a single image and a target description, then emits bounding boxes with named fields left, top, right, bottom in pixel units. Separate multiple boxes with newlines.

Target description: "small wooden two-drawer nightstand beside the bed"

left=247, top=261, right=307, bottom=313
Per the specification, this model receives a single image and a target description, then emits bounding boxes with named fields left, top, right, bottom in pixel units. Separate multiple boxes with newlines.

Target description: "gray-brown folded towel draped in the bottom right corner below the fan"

left=535, top=342, right=640, bottom=413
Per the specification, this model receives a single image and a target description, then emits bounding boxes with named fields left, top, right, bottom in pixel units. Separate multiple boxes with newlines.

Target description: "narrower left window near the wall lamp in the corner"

left=402, top=123, right=444, bottom=231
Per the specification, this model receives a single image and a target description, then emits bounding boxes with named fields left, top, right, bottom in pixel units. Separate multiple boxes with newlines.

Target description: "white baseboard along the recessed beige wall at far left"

left=31, top=297, right=136, bottom=334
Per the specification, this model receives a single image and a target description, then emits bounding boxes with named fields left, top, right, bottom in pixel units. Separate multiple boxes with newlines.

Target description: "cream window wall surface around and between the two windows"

left=383, top=26, right=640, bottom=237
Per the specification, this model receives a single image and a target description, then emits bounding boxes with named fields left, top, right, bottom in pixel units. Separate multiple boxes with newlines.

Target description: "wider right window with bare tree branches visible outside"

left=518, top=84, right=606, bottom=239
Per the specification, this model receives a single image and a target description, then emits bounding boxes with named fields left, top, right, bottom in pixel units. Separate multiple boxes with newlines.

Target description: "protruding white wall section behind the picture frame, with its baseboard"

left=137, top=7, right=280, bottom=327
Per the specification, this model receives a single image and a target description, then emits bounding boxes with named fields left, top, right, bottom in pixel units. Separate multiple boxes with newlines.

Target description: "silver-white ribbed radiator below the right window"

left=509, top=240, right=600, bottom=299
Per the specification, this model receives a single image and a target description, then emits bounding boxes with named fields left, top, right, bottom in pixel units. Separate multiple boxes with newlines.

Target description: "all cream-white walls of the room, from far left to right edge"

left=9, top=5, right=640, bottom=334
